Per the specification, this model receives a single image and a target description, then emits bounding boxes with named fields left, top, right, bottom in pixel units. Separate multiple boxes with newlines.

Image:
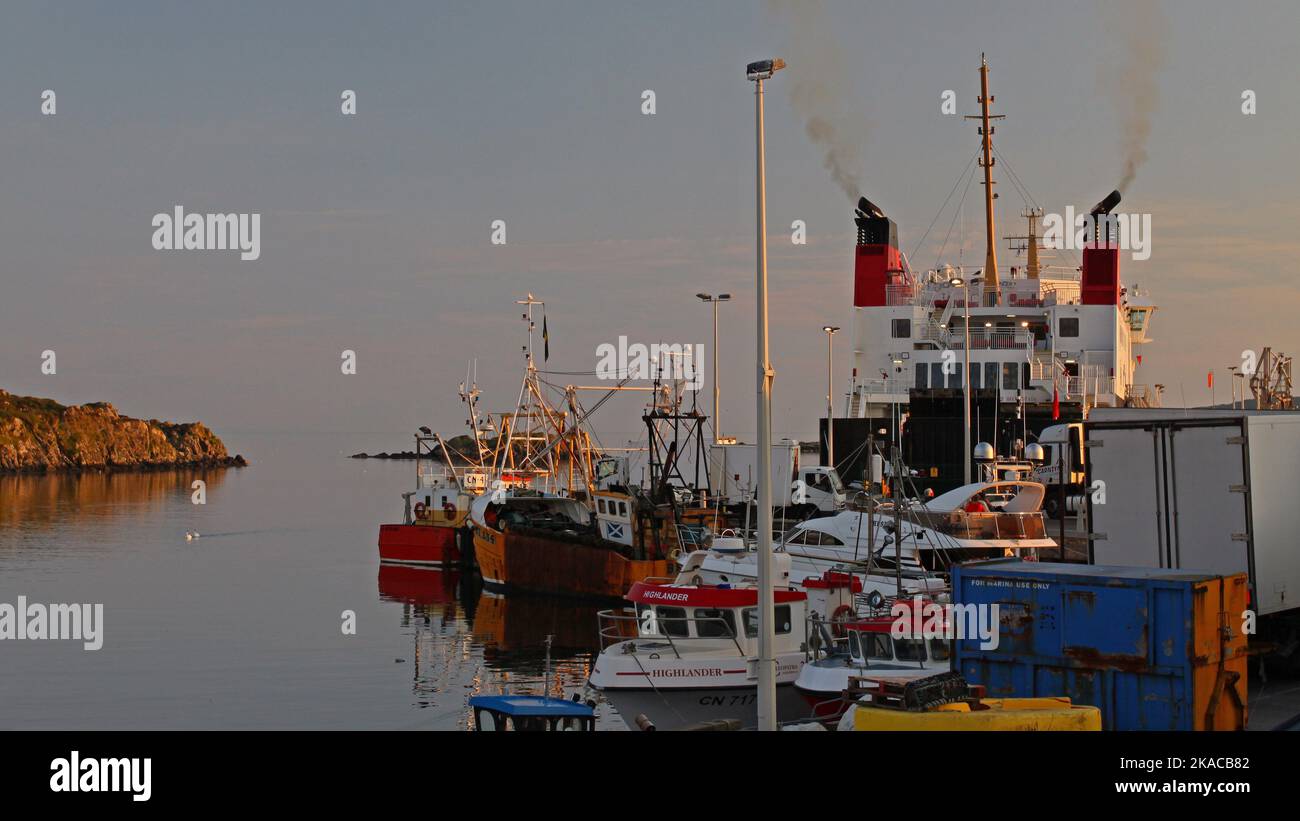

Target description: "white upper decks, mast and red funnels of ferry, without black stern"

left=844, top=56, right=1160, bottom=436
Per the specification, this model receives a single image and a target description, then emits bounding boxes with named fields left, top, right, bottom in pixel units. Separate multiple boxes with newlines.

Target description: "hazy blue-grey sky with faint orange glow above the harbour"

left=0, top=0, right=1300, bottom=448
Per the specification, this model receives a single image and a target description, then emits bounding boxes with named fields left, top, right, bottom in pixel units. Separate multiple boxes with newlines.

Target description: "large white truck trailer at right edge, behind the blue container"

left=1084, top=408, right=1300, bottom=664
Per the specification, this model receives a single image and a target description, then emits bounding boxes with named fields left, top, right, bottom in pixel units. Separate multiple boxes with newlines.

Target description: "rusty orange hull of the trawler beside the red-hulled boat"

left=475, top=527, right=676, bottom=600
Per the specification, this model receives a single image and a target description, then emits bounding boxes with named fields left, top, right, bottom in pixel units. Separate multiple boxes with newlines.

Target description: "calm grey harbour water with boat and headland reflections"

left=0, top=434, right=623, bottom=730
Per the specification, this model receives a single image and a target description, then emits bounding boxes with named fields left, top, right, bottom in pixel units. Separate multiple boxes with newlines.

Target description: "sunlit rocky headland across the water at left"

left=0, top=390, right=248, bottom=475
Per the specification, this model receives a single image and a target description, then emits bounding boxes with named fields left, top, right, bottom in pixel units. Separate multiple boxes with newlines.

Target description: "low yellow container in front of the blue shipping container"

left=853, top=698, right=1101, bottom=731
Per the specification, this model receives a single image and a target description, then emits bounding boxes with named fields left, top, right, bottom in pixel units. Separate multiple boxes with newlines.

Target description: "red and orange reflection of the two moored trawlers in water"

left=380, top=565, right=621, bottom=729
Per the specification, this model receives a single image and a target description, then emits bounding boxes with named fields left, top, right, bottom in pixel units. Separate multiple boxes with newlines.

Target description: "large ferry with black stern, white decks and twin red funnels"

left=823, top=60, right=1160, bottom=492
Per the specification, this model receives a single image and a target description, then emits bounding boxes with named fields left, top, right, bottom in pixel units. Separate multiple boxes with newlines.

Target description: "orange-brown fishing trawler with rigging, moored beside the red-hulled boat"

left=469, top=295, right=705, bottom=599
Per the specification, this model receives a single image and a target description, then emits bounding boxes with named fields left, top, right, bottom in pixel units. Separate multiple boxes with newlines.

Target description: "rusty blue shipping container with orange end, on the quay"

left=952, top=559, right=1248, bottom=730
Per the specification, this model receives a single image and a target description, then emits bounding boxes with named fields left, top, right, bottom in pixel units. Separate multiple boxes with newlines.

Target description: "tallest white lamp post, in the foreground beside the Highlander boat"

left=745, top=58, right=785, bottom=730
